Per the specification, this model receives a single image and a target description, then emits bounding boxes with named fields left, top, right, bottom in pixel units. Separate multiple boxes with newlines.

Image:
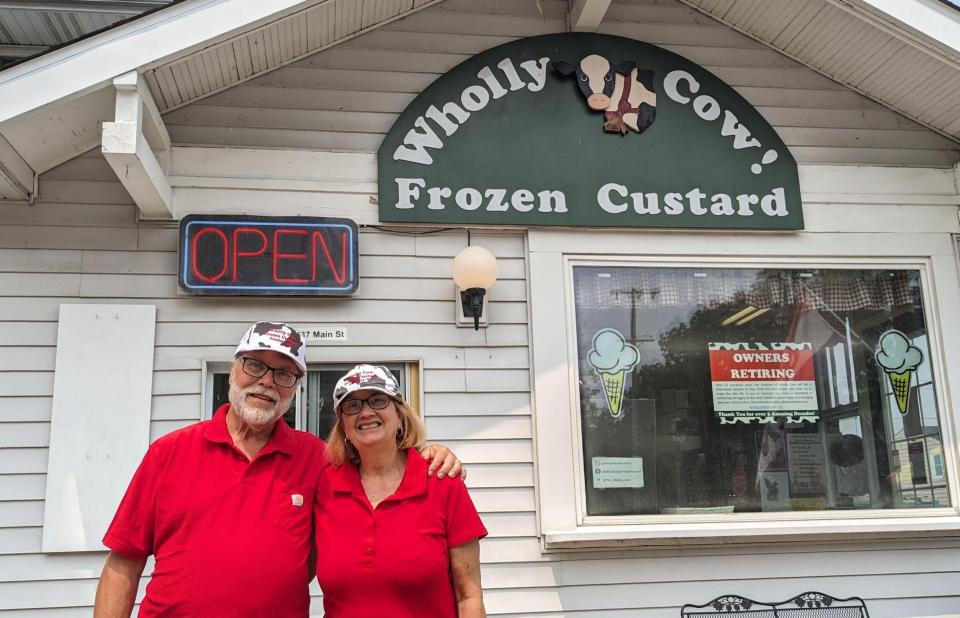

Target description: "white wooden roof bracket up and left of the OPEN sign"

left=101, top=71, right=171, bottom=219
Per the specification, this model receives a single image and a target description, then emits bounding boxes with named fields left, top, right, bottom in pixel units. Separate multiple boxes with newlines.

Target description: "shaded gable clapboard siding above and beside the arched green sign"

left=159, top=0, right=960, bottom=165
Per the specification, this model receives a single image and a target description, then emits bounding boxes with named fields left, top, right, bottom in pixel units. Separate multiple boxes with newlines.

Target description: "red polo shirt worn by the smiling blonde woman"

left=315, top=449, right=487, bottom=618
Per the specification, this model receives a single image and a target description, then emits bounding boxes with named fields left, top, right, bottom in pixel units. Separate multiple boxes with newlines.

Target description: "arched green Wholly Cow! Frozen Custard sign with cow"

left=378, top=33, right=803, bottom=230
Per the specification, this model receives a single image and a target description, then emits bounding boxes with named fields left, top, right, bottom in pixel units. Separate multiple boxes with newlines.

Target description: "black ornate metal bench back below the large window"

left=680, top=592, right=870, bottom=618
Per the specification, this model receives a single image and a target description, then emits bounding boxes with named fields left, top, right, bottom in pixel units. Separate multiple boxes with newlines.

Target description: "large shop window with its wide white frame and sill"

left=529, top=241, right=960, bottom=551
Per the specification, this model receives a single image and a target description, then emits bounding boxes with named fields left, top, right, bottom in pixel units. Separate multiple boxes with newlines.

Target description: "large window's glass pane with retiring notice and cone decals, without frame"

left=572, top=265, right=950, bottom=516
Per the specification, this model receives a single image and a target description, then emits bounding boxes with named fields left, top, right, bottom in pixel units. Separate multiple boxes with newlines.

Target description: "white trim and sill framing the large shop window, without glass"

left=529, top=230, right=960, bottom=551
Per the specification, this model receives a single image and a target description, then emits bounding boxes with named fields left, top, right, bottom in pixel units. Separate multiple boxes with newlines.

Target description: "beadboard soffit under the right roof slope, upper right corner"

left=680, top=0, right=960, bottom=141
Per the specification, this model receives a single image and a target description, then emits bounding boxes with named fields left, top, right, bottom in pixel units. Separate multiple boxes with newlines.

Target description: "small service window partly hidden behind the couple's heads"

left=210, top=361, right=419, bottom=438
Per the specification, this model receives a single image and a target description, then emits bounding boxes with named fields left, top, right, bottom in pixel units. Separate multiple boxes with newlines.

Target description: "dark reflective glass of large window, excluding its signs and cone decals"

left=574, top=266, right=949, bottom=515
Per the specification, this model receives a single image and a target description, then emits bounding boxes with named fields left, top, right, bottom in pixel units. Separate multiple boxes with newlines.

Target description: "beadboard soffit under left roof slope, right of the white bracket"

left=144, top=0, right=442, bottom=112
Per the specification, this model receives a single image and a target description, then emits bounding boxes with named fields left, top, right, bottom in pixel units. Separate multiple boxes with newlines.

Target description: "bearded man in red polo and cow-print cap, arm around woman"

left=94, top=322, right=460, bottom=618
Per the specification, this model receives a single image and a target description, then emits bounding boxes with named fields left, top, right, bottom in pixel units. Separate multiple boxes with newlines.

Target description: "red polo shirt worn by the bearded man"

left=103, top=404, right=327, bottom=618
